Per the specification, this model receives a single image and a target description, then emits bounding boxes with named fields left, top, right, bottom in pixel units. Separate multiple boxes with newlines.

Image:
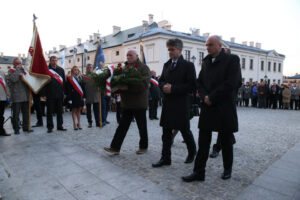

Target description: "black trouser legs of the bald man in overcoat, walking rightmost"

left=194, top=129, right=233, bottom=173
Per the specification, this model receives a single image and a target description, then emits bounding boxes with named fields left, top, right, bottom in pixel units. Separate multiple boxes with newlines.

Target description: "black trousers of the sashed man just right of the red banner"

left=46, top=99, right=63, bottom=130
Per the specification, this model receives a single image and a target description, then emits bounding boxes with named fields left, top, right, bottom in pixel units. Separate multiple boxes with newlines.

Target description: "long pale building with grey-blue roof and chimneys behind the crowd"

left=47, top=15, right=285, bottom=84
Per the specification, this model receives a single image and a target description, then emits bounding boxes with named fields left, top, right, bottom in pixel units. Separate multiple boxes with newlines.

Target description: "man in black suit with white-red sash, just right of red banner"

left=44, top=56, right=67, bottom=133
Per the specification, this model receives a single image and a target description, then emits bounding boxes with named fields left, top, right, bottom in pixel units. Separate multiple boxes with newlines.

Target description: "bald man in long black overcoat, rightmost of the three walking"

left=182, top=36, right=242, bottom=182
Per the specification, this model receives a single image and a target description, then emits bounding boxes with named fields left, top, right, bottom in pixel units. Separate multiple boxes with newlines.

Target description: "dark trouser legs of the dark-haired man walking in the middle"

left=162, top=127, right=196, bottom=160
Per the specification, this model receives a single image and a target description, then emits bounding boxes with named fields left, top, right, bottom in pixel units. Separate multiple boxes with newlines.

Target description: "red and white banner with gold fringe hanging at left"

left=22, top=25, right=51, bottom=94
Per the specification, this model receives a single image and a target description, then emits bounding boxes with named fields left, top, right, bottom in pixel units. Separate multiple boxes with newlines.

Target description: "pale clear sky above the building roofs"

left=0, top=0, right=300, bottom=75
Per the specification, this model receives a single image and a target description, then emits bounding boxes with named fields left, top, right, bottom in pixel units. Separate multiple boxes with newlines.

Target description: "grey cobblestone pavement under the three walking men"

left=0, top=108, right=300, bottom=200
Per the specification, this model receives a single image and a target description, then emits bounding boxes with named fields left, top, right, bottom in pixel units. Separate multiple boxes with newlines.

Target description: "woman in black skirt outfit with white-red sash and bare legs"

left=66, top=66, right=84, bottom=130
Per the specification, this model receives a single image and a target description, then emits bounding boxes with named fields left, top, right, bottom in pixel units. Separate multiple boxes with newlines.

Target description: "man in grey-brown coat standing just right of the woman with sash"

left=82, top=64, right=100, bottom=128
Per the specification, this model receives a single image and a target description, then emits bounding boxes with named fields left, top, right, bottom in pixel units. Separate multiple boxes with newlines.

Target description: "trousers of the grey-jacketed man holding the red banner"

left=12, top=101, right=29, bottom=131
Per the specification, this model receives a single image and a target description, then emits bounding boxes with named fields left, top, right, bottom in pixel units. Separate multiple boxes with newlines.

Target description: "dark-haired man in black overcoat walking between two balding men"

left=152, top=39, right=196, bottom=167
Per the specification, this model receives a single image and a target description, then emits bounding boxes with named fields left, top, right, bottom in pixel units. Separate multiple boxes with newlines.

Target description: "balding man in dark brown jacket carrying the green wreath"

left=104, top=50, right=150, bottom=155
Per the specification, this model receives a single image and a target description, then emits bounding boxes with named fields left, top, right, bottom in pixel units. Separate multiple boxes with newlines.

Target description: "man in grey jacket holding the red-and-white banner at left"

left=8, top=58, right=33, bottom=135
